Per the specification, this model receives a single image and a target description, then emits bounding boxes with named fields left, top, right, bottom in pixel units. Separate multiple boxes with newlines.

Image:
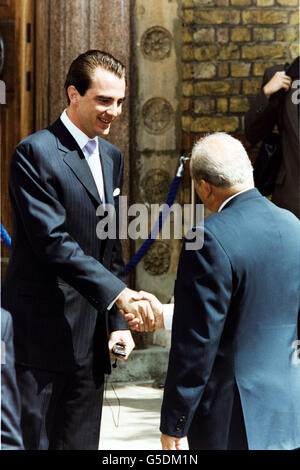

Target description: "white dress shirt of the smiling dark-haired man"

left=60, top=109, right=105, bottom=204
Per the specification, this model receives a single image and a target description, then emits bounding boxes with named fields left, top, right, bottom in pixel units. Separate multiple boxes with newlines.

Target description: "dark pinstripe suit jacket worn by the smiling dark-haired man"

left=3, top=119, right=128, bottom=378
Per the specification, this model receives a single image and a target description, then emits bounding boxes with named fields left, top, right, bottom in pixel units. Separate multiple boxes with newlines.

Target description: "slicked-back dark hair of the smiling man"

left=65, top=49, right=125, bottom=104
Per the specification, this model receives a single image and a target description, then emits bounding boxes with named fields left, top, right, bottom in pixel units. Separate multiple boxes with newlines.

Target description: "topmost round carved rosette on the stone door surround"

left=141, top=26, right=172, bottom=62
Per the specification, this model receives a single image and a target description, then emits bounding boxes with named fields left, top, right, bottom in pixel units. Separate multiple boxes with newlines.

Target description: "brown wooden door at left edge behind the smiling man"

left=0, top=0, right=35, bottom=278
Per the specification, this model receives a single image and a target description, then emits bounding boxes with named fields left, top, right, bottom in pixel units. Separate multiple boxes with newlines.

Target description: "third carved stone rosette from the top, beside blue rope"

left=141, top=169, right=171, bottom=204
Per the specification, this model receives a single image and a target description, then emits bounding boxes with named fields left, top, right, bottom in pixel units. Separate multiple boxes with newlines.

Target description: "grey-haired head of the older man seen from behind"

left=190, top=132, right=254, bottom=212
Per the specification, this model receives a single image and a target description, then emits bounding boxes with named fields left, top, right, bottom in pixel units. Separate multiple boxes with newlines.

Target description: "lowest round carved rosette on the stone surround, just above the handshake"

left=143, top=241, right=171, bottom=276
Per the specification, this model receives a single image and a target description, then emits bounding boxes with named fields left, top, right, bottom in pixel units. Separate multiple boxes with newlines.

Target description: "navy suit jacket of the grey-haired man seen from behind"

left=161, top=189, right=300, bottom=449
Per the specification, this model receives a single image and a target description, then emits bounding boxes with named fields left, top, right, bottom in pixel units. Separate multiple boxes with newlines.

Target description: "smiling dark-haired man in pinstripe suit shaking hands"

left=2, top=50, right=157, bottom=450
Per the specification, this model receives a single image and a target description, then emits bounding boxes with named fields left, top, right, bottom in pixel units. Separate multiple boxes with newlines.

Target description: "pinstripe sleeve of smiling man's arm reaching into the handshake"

left=10, top=144, right=126, bottom=311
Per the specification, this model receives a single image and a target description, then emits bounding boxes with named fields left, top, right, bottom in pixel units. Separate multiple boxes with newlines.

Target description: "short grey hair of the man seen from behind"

left=190, top=132, right=253, bottom=189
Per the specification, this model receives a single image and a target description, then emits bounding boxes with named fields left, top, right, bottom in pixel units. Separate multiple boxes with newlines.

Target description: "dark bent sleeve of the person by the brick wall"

left=245, top=69, right=279, bottom=144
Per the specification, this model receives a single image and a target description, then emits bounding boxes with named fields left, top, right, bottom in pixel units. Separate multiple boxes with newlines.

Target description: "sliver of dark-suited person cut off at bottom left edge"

left=1, top=308, right=24, bottom=450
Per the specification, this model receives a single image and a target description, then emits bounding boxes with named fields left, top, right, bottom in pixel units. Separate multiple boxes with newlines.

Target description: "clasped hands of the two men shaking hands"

left=116, top=287, right=164, bottom=331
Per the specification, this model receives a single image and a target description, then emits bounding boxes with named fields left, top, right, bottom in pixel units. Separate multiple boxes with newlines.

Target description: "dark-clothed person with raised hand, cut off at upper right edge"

left=245, top=57, right=300, bottom=218
